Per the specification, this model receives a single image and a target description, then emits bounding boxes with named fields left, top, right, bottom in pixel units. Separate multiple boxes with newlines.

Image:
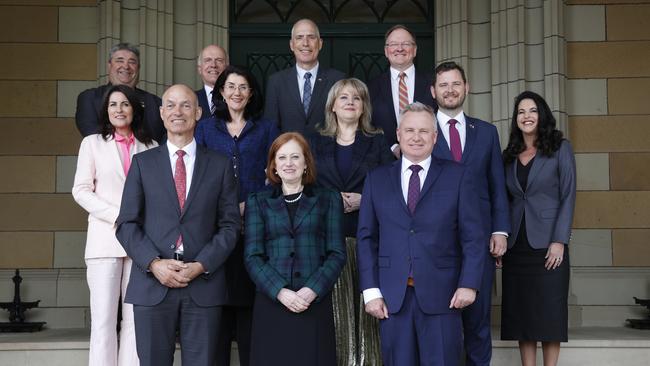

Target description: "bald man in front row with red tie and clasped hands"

left=116, top=85, right=241, bottom=366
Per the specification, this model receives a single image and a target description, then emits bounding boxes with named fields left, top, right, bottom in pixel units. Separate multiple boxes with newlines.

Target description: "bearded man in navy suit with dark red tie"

left=431, top=62, right=510, bottom=366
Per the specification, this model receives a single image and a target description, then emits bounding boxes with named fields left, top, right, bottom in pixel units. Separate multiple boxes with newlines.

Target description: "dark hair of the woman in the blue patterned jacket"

left=212, top=65, right=264, bottom=122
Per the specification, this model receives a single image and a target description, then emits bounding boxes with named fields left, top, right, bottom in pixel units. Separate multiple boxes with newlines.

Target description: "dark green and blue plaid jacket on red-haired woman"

left=244, top=186, right=346, bottom=301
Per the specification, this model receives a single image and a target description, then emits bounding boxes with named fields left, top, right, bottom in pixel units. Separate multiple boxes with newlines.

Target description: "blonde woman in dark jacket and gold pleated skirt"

left=310, top=78, right=395, bottom=366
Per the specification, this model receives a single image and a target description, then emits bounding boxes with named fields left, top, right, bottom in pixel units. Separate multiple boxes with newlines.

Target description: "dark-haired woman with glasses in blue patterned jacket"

left=194, top=66, right=278, bottom=365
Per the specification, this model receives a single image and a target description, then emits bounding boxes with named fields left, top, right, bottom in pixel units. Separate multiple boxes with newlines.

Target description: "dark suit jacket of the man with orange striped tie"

left=368, top=70, right=437, bottom=147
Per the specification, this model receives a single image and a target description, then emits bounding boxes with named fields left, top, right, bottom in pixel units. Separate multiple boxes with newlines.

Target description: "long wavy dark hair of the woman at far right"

left=503, top=90, right=564, bottom=164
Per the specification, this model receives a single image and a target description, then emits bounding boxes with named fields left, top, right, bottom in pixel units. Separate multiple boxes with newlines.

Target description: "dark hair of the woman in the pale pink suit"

left=99, top=85, right=152, bottom=145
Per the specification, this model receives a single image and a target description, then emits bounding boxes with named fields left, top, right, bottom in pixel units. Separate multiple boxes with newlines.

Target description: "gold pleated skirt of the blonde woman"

left=332, top=238, right=382, bottom=366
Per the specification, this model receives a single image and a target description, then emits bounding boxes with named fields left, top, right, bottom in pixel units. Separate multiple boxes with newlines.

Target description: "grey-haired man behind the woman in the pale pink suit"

left=75, top=43, right=165, bottom=143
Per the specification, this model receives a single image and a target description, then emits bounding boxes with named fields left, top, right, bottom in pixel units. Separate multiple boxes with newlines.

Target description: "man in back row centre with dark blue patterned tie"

left=264, top=19, right=345, bottom=135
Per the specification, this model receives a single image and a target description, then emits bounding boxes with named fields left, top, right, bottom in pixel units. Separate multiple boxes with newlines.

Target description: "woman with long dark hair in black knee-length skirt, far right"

left=501, top=91, right=576, bottom=366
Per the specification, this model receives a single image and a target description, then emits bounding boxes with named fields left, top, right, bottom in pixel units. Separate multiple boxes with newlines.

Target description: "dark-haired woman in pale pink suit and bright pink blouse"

left=72, top=85, right=156, bottom=366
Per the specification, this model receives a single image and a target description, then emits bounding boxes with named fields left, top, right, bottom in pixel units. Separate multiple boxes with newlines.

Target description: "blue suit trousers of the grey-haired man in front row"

left=379, top=284, right=462, bottom=366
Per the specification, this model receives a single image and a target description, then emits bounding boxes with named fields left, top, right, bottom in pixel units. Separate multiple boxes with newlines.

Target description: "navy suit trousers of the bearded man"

left=463, top=253, right=495, bottom=366
